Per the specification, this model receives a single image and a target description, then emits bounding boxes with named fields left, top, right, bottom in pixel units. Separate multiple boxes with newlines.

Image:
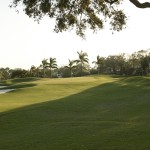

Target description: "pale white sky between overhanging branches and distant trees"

left=0, top=0, right=150, bottom=69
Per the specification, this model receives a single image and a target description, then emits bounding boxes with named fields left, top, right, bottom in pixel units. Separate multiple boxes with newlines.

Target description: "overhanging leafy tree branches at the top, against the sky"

left=10, top=0, right=150, bottom=37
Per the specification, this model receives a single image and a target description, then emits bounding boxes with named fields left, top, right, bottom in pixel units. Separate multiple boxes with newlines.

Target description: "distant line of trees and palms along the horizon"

left=0, top=49, right=150, bottom=80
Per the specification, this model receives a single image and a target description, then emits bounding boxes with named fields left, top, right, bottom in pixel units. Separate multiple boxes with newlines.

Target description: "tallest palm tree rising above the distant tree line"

left=76, top=51, right=89, bottom=75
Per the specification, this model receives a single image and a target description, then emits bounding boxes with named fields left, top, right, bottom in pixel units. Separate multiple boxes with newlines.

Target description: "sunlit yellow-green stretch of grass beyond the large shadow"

left=0, top=76, right=114, bottom=112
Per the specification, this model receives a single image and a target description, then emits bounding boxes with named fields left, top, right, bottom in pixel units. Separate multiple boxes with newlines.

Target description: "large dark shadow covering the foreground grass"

left=0, top=77, right=150, bottom=150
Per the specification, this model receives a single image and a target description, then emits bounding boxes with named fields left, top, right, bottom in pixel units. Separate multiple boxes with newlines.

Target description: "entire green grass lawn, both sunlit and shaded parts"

left=0, top=76, right=150, bottom=150
